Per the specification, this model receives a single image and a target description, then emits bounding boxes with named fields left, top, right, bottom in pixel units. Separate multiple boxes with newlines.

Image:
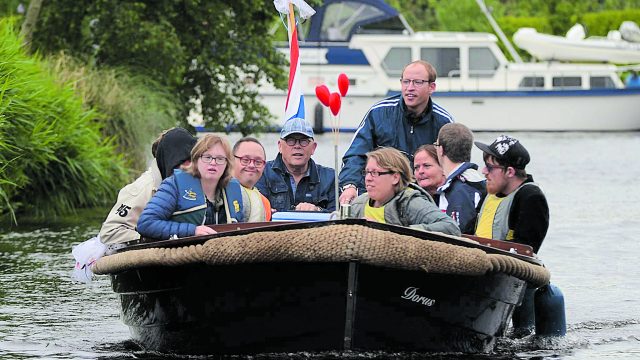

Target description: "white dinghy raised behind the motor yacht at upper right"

left=513, top=24, right=640, bottom=64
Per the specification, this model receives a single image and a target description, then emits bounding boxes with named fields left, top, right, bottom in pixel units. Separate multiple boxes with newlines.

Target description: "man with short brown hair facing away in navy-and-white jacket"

left=434, top=123, right=487, bottom=234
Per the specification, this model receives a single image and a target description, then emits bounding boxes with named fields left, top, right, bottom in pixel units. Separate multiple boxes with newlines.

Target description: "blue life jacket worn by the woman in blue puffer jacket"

left=171, top=170, right=244, bottom=225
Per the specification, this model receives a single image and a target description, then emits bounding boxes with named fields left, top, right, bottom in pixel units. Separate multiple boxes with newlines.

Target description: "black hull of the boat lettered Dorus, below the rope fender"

left=112, top=262, right=527, bottom=354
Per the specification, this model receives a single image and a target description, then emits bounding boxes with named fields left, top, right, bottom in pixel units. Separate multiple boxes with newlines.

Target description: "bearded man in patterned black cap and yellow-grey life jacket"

left=475, top=135, right=549, bottom=253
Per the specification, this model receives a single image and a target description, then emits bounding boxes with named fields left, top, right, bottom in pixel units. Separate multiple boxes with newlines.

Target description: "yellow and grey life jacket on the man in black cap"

left=476, top=182, right=538, bottom=240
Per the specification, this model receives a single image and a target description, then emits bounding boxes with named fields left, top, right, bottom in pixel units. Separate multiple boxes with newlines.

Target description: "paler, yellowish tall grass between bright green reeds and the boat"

left=47, top=53, right=180, bottom=170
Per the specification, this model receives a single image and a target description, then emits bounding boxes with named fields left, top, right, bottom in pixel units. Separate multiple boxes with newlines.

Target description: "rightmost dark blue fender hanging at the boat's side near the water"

left=535, top=284, right=567, bottom=336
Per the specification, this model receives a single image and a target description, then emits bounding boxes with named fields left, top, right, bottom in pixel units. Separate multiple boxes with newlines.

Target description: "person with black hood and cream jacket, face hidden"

left=100, top=127, right=196, bottom=245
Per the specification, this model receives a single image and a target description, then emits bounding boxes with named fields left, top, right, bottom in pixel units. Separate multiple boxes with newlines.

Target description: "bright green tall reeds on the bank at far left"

left=0, top=20, right=128, bottom=222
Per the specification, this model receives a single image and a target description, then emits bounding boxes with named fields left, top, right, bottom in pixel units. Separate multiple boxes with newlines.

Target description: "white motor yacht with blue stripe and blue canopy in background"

left=259, top=0, right=640, bottom=132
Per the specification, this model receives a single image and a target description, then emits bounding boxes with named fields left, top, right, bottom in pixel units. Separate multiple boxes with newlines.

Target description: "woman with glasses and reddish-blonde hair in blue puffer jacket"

left=137, top=134, right=244, bottom=239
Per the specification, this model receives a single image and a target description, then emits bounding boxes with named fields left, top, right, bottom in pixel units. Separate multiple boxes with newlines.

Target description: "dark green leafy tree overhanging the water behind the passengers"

left=34, top=0, right=286, bottom=133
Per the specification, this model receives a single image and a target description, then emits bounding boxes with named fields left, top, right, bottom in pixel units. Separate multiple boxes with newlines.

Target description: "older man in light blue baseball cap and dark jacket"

left=256, top=118, right=336, bottom=212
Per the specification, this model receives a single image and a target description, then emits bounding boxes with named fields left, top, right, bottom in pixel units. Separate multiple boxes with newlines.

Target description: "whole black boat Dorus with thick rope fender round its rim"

left=93, top=219, right=549, bottom=354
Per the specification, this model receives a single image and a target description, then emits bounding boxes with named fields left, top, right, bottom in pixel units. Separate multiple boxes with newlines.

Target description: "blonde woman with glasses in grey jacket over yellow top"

left=351, top=148, right=460, bottom=235
